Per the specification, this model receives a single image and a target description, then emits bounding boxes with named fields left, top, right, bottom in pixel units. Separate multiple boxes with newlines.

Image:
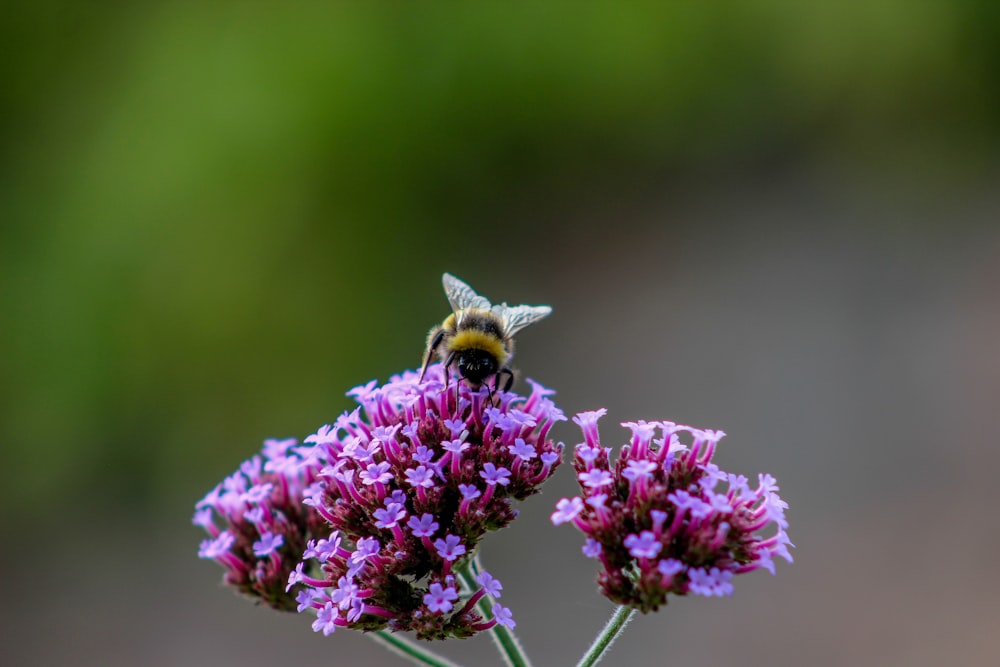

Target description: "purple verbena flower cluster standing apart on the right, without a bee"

left=552, top=409, right=793, bottom=612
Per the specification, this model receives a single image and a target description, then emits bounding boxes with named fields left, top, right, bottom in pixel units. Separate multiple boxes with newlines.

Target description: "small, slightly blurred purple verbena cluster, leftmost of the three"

left=193, top=438, right=325, bottom=611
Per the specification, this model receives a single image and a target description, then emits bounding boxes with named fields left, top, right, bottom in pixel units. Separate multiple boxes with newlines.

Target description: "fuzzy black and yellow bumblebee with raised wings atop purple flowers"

left=420, top=273, right=552, bottom=391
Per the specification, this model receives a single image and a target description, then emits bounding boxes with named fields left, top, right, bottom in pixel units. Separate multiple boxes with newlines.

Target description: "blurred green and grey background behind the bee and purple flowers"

left=0, top=0, right=1000, bottom=667
